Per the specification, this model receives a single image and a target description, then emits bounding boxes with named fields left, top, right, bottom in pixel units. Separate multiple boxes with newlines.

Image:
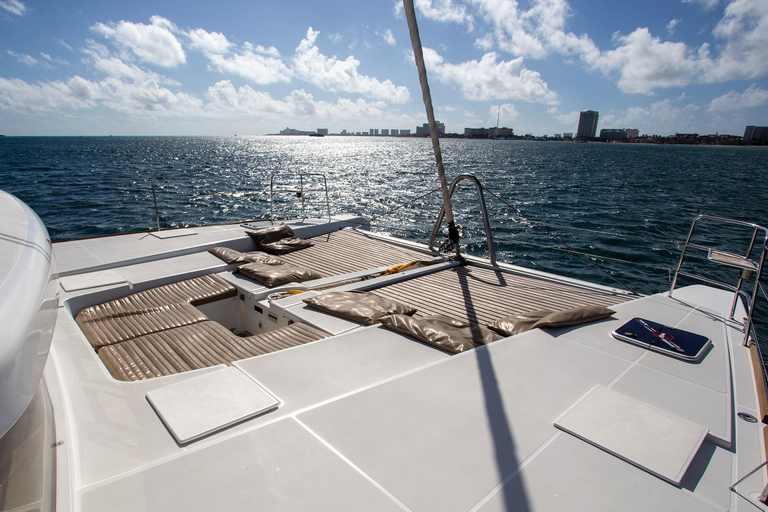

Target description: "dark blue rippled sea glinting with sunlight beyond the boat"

left=0, top=137, right=768, bottom=348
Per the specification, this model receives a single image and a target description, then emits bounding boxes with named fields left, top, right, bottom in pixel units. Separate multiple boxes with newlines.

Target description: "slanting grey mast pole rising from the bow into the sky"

left=403, top=0, right=461, bottom=257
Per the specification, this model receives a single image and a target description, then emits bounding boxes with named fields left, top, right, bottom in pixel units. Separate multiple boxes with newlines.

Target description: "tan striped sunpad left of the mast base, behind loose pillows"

left=279, top=229, right=432, bottom=277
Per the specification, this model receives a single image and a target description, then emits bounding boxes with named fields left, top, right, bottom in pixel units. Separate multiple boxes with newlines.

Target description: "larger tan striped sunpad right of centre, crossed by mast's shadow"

left=373, top=266, right=631, bottom=325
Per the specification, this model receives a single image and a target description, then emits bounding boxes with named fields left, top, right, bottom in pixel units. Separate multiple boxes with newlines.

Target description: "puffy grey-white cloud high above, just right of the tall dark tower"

left=595, top=28, right=705, bottom=94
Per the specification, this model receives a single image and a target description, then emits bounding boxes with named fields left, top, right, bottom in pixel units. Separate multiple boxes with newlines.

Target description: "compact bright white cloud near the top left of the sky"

left=91, top=16, right=186, bottom=67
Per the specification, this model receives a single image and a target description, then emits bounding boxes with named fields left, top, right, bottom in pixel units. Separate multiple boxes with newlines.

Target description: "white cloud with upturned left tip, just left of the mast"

left=292, top=27, right=410, bottom=103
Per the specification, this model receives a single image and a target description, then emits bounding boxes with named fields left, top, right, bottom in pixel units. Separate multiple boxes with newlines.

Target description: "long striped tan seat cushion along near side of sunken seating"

left=98, top=321, right=328, bottom=381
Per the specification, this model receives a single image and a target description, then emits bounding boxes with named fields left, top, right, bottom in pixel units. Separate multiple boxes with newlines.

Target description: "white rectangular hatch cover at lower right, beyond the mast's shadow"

left=554, top=386, right=708, bottom=485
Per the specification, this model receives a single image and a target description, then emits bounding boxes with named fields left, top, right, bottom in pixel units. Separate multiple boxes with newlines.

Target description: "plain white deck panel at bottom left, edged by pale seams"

left=81, top=419, right=402, bottom=512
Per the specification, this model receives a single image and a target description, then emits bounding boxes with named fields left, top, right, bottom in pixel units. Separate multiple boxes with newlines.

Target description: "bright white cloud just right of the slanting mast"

left=424, top=48, right=557, bottom=104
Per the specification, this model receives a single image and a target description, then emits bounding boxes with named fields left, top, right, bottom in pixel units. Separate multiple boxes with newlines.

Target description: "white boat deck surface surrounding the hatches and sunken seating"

left=44, top=222, right=765, bottom=511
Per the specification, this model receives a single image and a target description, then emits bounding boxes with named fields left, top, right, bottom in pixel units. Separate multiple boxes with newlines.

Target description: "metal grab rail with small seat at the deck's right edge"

left=668, top=215, right=768, bottom=346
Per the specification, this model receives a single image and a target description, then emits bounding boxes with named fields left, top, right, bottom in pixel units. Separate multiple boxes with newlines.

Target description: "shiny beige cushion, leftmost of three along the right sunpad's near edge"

left=304, top=291, right=416, bottom=325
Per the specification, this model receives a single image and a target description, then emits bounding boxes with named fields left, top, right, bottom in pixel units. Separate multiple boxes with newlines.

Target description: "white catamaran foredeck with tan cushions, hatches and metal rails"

left=0, top=2, right=768, bottom=512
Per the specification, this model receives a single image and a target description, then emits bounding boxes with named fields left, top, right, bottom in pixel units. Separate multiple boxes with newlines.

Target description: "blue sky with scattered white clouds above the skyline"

left=0, top=0, right=768, bottom=135
